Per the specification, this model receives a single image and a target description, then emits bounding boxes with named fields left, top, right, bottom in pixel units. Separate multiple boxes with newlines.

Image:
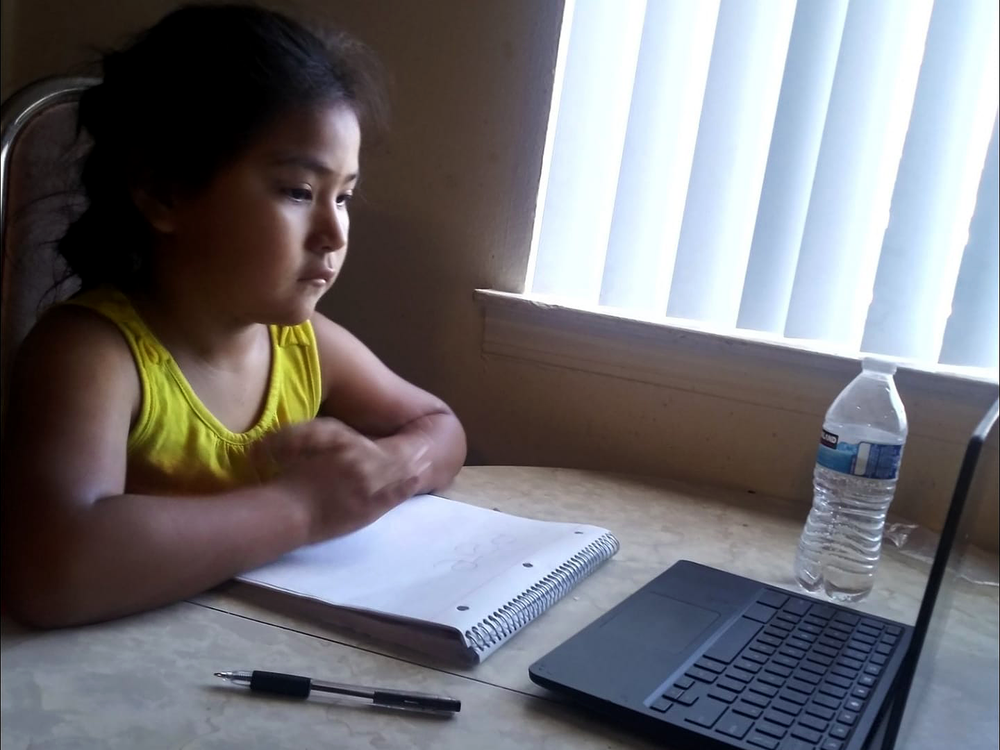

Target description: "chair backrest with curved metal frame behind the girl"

left=0, top=78, right=98, bottom=420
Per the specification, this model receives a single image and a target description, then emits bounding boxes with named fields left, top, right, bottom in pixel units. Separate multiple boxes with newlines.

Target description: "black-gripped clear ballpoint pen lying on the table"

left=215, top=670, right=462, bottom=713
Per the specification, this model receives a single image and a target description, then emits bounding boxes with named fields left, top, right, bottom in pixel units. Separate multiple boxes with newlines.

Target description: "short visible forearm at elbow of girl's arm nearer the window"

left=376, top=412, right=466, bottom=492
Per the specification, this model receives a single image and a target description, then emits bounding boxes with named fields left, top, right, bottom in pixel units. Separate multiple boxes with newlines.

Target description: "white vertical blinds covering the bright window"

left=525, top=0, right=1000, bottom=370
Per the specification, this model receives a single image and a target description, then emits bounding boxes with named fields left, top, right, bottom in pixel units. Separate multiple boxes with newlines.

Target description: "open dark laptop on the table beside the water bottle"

left=529, top=402, right=1000, bottom=750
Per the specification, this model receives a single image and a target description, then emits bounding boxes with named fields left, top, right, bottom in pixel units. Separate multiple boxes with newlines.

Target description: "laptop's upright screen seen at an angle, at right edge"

left=887, top=405, right=1000, bottom=750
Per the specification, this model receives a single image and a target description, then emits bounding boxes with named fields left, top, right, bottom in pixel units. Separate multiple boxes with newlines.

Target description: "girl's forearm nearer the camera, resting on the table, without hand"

left=4, top=483, right=308, bottom=627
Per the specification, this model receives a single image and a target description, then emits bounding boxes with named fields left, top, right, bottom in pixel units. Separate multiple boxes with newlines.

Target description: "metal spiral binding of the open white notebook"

left=465, top=533, right=621, bottom=653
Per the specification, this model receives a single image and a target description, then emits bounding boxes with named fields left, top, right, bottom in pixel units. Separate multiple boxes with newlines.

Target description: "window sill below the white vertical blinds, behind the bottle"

left=475, top=289, right=997, bottom=444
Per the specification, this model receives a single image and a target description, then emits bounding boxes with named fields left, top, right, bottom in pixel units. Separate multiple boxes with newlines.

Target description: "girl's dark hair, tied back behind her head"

left=58, top=5, right=385, bottom=290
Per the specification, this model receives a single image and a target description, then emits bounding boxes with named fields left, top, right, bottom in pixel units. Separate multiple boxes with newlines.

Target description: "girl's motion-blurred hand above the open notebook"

left=258, top=417, right=428, bottom=543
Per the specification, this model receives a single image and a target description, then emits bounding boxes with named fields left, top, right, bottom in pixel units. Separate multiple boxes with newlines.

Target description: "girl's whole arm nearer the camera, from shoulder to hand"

left=0, top=309, right=396, bottom=627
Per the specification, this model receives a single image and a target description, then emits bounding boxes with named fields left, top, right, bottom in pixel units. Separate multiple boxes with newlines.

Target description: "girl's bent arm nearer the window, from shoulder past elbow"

left=312, top=313, right=466, bottom=493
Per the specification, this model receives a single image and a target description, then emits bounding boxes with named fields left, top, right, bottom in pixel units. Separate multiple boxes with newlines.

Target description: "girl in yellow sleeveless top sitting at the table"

left=2, top=5, right=465, bottom=627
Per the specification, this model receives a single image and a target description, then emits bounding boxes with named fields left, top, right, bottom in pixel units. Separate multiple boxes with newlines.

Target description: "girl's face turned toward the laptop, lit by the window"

left=159, top=105, right=361, bottom=325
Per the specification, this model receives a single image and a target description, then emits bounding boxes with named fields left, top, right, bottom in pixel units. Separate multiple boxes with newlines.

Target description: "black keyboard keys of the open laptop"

left=649, top=589, right=902, bottom=750
